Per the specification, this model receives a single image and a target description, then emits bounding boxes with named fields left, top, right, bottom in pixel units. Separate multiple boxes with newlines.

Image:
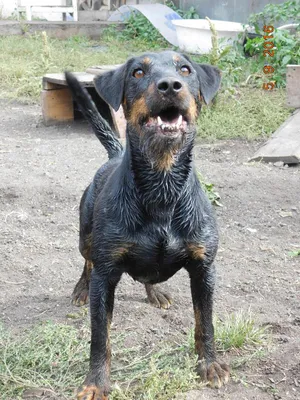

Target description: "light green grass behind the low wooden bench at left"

left=0, top=31, right=152, bottom=102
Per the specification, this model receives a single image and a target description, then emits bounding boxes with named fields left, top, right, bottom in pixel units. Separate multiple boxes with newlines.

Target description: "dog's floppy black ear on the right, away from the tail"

left=192, top=62, right=221, bottom=104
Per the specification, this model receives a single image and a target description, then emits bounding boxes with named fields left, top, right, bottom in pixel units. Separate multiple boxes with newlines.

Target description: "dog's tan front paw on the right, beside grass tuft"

left=197, top=360, right=230, bottom=389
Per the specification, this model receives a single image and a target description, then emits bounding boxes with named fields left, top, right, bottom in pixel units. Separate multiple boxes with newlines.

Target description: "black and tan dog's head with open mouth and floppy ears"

left=95, top=51, right=221, bottom=169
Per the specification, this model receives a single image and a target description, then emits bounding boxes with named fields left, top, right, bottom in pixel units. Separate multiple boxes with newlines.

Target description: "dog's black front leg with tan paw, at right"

left=189, top=264, right=229, bottom=388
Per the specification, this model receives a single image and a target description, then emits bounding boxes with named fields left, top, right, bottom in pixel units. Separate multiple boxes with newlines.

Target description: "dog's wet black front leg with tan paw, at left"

left=77, top=264, right=121, bottom=400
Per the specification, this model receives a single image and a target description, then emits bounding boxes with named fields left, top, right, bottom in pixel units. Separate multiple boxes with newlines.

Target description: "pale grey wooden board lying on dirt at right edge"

left=250, top=110, right=300, bottom=164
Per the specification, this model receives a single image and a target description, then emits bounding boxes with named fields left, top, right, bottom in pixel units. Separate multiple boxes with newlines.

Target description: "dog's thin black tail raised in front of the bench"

left=65, top=72, right=123, bottom=158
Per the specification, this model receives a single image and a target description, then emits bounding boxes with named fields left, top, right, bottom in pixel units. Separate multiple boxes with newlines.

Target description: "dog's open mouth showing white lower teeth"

left=145, top=107, right=187, bottom=135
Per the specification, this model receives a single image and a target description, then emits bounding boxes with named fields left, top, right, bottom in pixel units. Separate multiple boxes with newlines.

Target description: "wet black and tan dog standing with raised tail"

left=66, top=51, right=229, bottom=400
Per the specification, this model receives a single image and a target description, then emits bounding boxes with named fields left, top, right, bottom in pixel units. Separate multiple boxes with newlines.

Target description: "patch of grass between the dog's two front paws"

left=111, top=343, right=199, bottom=400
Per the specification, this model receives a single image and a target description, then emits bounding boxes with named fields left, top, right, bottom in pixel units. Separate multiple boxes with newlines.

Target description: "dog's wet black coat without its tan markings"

left=66, top=52, right=227, bottom=399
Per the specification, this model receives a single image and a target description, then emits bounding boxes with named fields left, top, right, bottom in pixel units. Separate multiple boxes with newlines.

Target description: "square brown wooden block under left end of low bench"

left=41, top=88, right=74, bottom=125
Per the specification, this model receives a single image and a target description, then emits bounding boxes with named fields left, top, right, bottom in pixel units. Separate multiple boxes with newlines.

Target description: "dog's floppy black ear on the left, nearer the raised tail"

left=94, top=63, right=127, bottom=111
